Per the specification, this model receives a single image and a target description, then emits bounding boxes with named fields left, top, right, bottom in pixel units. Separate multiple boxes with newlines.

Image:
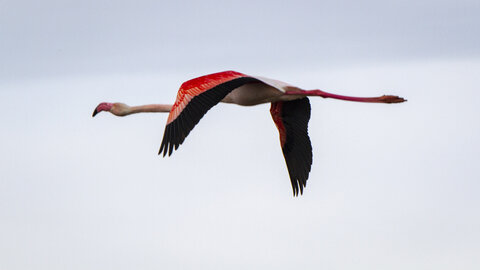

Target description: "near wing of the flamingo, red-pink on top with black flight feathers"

left=158, top=71, right=260, bottom=156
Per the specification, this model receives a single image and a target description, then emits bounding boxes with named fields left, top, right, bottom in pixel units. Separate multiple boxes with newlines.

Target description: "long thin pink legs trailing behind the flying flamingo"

left=285, top=90, right=407, bottom=103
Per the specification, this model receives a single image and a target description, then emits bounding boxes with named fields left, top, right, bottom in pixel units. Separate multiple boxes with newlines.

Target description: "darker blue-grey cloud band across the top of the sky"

left=0, top=0, right=480, bottom=80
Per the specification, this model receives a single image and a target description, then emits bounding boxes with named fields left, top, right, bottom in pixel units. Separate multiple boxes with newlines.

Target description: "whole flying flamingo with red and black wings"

left=92, top=71, right=406, bottom=196
